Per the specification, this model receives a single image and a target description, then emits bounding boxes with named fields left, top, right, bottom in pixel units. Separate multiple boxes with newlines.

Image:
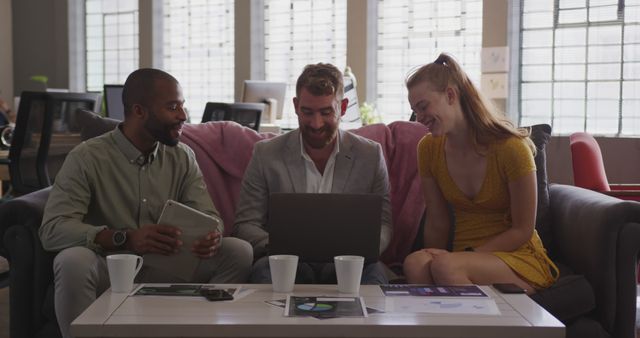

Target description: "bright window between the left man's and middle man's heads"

left=163, top=0, right=235, bottom=123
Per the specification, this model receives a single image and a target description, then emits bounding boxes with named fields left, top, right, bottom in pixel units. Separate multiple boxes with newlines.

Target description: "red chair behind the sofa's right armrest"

left=569, top=132, right=640, bottom=201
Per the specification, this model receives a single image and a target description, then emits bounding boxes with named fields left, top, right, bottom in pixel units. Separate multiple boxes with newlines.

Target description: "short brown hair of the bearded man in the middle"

left=296, top=63, right=344, bottom=100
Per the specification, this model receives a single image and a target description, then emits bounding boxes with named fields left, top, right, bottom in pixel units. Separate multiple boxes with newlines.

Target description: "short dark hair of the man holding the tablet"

left=122, top=68, right=178, bottom=116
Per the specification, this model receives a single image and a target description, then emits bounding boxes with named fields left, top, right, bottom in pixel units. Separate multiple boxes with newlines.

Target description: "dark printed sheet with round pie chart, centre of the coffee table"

left=284, top=296, right=367, bottom=319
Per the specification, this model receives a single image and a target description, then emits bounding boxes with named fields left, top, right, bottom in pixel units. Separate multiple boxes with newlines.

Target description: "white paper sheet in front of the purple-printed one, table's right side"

left=386, top=297, right=500, bottom=315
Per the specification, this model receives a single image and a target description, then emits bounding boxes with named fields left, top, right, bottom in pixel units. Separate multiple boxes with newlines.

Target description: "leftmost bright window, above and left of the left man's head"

left=85, top=0, right=138, bottom=91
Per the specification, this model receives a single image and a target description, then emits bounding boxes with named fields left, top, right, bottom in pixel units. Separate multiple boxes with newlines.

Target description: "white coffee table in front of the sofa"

left=71, top=284, right=565, bottom=338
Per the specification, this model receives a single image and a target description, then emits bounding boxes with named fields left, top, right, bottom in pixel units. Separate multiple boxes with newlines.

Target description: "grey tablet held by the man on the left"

left=144, top=200, right=222, bottom=281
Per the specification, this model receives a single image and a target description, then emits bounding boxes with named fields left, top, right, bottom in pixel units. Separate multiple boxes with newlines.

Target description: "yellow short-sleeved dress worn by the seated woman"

left=418, top=134, right=558, bottom=289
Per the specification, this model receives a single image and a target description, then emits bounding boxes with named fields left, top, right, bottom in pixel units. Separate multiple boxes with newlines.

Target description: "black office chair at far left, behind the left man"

left=9, top=92, right=100, bottom=195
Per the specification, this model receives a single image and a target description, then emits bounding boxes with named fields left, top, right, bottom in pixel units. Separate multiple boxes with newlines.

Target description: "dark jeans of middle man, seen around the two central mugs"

left=250, top=256, right=389, bottom=285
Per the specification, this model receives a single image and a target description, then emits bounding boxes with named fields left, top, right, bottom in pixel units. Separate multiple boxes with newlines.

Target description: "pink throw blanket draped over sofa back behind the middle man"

left=181, top=121, right=426, bottom=266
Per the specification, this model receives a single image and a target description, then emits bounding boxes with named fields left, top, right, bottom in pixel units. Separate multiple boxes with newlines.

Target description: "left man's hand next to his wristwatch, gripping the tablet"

left=127, top=224, right=182, bottom=255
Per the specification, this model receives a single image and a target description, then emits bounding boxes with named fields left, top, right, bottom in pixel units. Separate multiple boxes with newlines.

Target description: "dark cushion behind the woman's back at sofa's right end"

left=530, top=124, right=554, bottom=257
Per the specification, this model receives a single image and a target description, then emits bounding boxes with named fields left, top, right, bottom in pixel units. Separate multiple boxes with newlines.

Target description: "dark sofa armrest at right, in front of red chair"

left=549, top=184, right=640, bottom=337
